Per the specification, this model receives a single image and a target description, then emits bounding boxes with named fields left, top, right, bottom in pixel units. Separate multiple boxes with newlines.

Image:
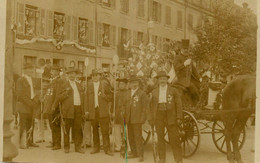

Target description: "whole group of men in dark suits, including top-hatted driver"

left=16, top=39, right=200, bottom=163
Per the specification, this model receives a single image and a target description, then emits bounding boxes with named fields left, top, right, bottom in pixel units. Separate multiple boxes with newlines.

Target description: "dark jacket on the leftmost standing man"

left=16, top=77, right=40, bottom=115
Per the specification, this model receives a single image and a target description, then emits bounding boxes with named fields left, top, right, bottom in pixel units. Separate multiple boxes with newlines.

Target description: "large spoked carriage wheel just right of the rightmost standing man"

left=179, top=111, right=200, bottom=158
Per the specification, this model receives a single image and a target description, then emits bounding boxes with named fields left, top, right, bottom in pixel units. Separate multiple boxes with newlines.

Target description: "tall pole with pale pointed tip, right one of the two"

left=112, top=55, right=119, bottom=152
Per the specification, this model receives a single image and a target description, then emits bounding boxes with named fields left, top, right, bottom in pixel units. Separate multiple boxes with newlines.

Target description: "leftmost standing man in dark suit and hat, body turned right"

left=16, top=64, right=40, bottom=148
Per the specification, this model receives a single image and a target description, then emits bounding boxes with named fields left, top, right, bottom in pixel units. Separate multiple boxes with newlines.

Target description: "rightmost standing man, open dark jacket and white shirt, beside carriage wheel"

left=148, top=71, right=182, bottom=163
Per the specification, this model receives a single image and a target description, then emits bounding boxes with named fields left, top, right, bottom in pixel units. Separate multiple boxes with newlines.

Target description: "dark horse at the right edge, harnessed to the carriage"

left=222, top=75, right=256, bottom=163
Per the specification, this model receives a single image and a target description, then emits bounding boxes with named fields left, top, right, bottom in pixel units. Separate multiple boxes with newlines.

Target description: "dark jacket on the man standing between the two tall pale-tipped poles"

left=85, top=81, right=113, bottom=120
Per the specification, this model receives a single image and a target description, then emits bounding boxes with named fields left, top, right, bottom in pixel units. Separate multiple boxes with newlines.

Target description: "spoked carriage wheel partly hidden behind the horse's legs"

left=212, top=121, right=246, bottom=154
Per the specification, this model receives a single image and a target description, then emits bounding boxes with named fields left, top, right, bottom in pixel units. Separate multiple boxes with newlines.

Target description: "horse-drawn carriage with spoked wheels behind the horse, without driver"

left=143, top=77, right=255, bottom=158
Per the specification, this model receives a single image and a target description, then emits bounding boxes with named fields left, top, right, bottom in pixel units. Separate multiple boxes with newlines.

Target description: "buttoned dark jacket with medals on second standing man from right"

left=123, top=88, right=148, bottom=124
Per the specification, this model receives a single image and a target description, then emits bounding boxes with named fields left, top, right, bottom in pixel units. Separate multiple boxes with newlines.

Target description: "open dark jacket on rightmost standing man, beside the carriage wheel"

left=148, top=85, right=182, bottom=125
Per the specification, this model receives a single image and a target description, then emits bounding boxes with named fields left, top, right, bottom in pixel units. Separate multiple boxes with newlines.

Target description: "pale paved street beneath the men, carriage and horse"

left=13, top=119, right=255, bottom=163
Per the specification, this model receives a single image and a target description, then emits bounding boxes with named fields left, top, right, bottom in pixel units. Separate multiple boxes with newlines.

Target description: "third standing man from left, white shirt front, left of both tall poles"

left=57, top=67, right=84, bottom=153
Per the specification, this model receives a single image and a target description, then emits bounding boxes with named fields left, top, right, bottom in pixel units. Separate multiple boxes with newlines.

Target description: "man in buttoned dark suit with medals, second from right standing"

left=123, top=76, right=148, bottom=162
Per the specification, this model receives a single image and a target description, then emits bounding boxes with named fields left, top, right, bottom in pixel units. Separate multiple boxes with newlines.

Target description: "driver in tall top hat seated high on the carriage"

left=174, top=39, right=200, bottom=102
